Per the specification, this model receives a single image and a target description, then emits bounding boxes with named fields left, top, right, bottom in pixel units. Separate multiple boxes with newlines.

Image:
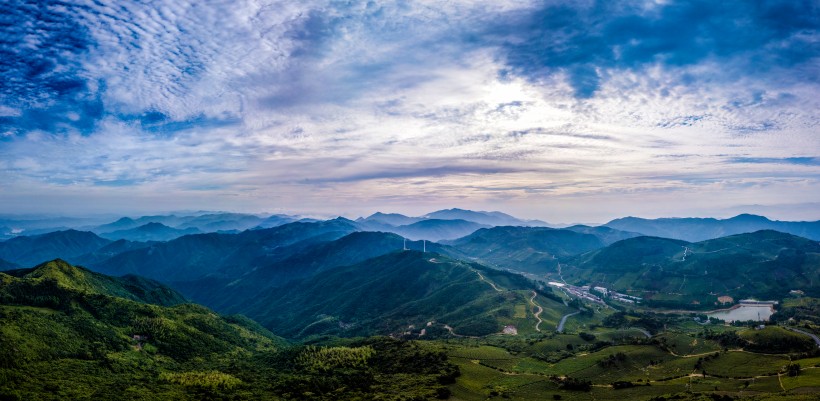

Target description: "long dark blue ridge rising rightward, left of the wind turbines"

left=89, top=219, right=357, bottom=282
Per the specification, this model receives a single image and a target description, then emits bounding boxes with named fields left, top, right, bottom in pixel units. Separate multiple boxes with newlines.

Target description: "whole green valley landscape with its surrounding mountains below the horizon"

left=0, top=210, right=820, bottom=401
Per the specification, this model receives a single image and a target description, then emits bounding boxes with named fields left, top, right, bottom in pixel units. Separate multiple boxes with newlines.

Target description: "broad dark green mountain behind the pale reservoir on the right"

left=562, top=230, right=820, bottom=307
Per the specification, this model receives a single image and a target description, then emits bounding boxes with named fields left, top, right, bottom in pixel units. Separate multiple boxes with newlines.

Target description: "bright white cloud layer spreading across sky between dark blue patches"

left=0, top=1, right=820, bottom=221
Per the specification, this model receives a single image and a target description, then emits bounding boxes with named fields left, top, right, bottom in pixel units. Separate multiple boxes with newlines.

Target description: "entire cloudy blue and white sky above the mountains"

left=0, top=0, right=820, bottom=223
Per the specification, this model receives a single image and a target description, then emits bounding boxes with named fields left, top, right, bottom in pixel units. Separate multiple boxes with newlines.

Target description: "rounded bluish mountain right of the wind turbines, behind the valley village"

left=444, top=226, right=614, bottom=274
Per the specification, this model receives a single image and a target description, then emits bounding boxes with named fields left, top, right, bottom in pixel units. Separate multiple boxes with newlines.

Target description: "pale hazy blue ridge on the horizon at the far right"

left=605, top=214, right=820, bottom=241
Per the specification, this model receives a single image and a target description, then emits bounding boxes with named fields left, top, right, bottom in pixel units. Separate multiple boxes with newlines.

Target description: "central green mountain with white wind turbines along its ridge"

left=242, top=251, right=568, bottom=338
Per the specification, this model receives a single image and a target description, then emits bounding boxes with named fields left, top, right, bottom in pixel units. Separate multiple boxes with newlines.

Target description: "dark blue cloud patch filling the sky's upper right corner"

left=486, top=0, right=820, bottom=98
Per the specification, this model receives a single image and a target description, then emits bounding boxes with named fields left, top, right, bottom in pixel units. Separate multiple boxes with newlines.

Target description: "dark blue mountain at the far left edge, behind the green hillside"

left=0, top=230, right=111, bottom=266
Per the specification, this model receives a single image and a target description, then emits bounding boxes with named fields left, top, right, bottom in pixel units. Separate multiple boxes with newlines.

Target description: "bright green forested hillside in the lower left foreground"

left=0, top=260, right=459, bottom=400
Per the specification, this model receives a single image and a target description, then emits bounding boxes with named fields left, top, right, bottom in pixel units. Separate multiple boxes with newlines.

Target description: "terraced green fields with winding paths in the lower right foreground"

left=445, top=330, right=820, bottom=401
